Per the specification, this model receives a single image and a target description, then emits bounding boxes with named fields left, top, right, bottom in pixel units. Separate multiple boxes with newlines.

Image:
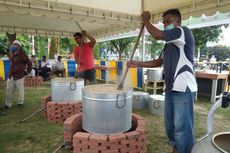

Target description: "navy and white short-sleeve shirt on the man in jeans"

left=162, top=27, right=197, bottom=92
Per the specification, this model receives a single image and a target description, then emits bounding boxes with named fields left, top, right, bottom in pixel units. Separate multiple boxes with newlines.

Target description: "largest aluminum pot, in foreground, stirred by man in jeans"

left=82, top=84, right=132, bottom=134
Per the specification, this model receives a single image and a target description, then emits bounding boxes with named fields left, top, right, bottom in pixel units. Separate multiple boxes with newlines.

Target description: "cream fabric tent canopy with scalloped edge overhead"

left=0, top=0, right=230, bottom=38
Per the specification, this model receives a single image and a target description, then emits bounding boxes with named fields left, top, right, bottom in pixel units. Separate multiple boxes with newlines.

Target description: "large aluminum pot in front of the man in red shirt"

left=51, top=77, right=84, bottom=102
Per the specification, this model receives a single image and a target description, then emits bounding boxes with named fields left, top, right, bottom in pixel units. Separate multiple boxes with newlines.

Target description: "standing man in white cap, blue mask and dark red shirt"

left=4, top=40, right=32, bottom=109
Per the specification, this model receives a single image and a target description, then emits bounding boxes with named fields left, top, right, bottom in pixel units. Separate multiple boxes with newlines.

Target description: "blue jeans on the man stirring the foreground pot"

left=164, top=89, right=195, bottom=153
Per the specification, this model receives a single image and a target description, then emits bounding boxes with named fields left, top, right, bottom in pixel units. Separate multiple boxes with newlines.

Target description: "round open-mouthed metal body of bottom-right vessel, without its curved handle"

left=192, top=132, right=230, bottom=153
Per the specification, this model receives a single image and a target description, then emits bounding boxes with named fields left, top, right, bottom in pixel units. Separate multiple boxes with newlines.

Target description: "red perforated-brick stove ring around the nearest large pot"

left=64, top=113, right=147, bottom=153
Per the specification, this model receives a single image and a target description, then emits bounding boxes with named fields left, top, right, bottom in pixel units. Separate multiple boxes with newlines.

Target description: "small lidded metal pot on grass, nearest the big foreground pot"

left=132, top=91, right=149, bottom=109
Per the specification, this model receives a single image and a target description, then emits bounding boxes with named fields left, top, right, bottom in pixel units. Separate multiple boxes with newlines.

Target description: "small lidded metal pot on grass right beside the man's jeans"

left=149, top=95, right=165, bottom=116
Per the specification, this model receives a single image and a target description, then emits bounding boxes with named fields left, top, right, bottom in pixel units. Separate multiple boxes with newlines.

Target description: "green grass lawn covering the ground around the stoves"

left=0, top=81, right=230, bottom=153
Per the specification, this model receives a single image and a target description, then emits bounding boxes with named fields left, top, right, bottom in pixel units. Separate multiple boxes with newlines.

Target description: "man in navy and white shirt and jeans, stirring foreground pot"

left=128, top=9, right=197, bottom=153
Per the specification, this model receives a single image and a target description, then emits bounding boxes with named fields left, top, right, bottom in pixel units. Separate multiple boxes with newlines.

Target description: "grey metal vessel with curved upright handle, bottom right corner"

left=192, top=93, right=230, bottom=153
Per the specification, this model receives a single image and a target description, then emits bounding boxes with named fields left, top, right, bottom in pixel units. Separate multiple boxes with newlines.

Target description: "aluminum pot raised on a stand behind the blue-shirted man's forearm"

left=147, top=68, right=163, bottom=81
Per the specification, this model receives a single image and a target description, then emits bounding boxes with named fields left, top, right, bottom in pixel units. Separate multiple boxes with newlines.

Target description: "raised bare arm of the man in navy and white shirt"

left=141, top=11, right=164, bottom=40
